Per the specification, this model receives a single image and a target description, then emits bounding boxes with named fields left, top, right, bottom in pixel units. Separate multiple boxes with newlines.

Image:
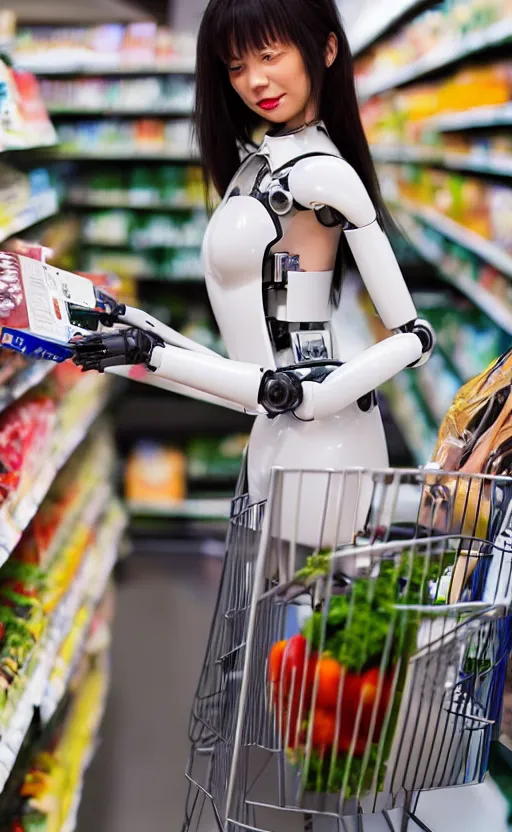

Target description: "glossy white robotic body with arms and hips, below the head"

left=115, top=120, right=428, bottom=547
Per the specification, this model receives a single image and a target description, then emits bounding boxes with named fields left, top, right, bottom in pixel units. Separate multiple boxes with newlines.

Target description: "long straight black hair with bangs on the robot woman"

left=195, top=0, right=393, bottom=300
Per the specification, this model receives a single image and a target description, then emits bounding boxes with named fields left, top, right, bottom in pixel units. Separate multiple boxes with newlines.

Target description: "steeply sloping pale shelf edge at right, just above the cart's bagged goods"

left=398, top=212, right=512, bottom=335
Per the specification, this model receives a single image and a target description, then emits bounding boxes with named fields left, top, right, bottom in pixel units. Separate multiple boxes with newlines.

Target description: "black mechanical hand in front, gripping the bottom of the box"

left=71, top=327, right=164, bottom=373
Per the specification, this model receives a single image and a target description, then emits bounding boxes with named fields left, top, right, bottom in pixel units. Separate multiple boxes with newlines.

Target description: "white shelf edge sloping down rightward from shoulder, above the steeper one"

left=391, top=199, right=512, bottom=278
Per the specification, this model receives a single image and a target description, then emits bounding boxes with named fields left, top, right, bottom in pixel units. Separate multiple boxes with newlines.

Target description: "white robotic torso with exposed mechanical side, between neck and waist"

left=203, top=124, right=340, bottom=368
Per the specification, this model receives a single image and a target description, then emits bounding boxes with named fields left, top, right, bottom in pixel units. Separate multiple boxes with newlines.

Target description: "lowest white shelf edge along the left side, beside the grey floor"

left=0, top=494, right=121, bottom=793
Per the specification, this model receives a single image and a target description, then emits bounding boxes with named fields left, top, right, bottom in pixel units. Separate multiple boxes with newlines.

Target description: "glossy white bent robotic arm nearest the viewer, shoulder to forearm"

left=288, top=156, right=434, bottom=420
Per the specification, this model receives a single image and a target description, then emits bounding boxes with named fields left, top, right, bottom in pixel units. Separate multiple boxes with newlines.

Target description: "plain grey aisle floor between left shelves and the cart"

left=77, top=555, right=222, bottom=832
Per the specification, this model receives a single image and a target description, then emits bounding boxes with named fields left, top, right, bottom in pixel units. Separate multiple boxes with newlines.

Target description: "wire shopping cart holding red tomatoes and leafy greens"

left=184, top=469, right=512, bottom=832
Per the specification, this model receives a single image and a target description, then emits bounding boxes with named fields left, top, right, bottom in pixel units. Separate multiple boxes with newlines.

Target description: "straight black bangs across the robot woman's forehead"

left=214, top=0, right=293, bottom=64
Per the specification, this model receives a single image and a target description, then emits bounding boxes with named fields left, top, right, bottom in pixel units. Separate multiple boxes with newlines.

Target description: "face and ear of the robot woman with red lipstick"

left=228, top=35, right=336, bottom=130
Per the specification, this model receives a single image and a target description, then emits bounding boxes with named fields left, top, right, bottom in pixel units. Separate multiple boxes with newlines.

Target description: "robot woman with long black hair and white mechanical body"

left=74, top=0, right=434, bottom=829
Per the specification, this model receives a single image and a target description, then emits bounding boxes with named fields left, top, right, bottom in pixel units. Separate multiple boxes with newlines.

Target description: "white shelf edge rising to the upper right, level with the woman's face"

left=358, top=18, right=512, bottom=100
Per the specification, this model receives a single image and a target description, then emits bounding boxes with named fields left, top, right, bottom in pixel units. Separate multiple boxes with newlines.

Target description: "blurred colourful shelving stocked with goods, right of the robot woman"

left=355, top=0, right=512, bottom=472
